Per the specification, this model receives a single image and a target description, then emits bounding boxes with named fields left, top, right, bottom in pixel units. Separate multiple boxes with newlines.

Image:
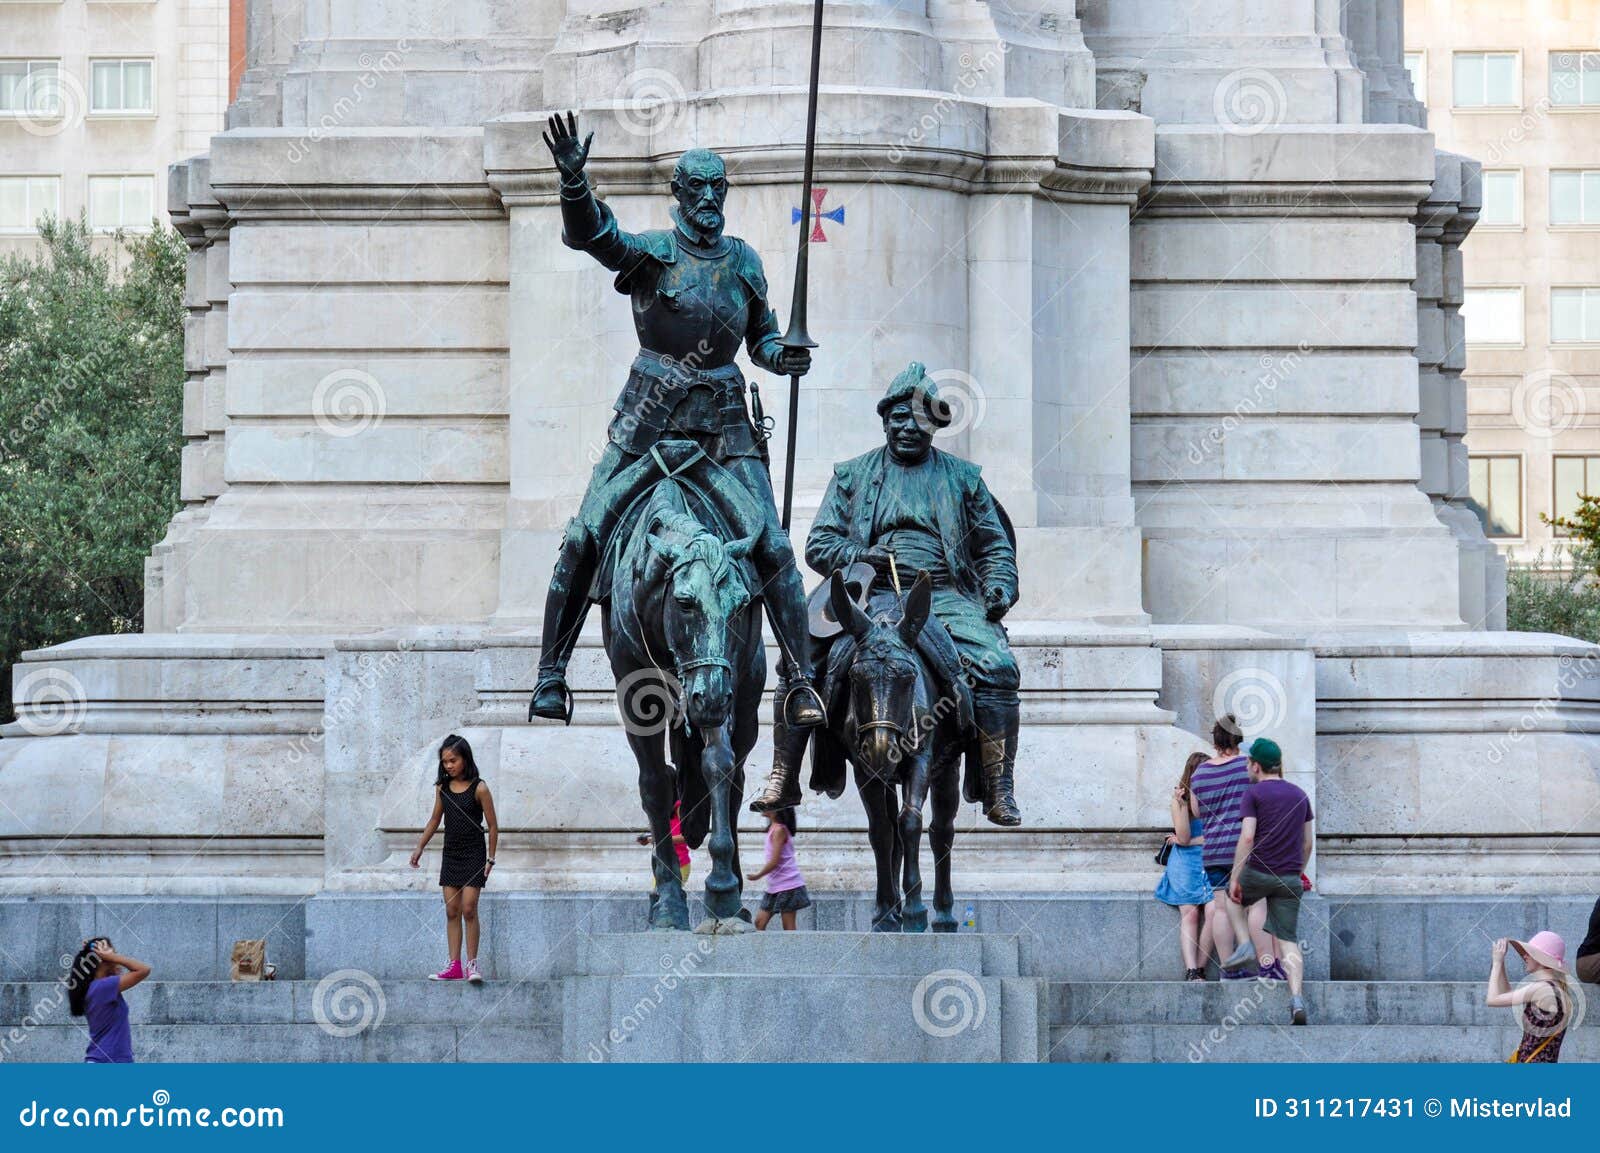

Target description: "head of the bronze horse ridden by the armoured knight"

left=646, top=513, right=755, bottom=729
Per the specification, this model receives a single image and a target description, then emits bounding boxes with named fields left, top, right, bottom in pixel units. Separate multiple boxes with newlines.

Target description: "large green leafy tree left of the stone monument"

left=0, top=217, right=186, bottom=716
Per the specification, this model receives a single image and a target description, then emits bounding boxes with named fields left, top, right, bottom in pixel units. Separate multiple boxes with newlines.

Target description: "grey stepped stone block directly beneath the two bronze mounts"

left=562, top=931, right=1045, bottom=1062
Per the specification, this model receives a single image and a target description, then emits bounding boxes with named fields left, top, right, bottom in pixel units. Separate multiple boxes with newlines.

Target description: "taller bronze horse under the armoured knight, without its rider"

left=602, top=478, right=766, bottom=932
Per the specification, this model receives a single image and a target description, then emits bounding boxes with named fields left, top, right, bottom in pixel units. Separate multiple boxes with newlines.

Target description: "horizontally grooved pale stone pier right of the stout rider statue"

left=1133, top=126, right=1461, bottom=630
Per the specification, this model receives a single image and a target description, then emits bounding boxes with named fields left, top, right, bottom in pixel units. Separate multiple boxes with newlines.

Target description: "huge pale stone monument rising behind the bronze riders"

left=0, top=0, right=1600, bottom=1010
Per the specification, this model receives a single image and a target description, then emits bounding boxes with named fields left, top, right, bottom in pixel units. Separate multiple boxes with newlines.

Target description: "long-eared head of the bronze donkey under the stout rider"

left=829, top=562, right=933, bottom=780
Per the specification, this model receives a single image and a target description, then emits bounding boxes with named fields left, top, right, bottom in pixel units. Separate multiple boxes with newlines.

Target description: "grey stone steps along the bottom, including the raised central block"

left=0, top=972, right=1600, bottom=1063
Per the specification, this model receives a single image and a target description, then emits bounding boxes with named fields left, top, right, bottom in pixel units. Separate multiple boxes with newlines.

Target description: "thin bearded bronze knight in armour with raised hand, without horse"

left=528, top=112, right=824, bottom=728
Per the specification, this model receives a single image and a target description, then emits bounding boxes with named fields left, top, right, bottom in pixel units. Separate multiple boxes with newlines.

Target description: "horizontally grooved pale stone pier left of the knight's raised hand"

left=170, top=128, right=506, bottom=632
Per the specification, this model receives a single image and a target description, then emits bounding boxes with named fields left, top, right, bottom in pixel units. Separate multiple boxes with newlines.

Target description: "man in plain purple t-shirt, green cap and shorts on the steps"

left=1222, top=737, right=1314, bottom=1025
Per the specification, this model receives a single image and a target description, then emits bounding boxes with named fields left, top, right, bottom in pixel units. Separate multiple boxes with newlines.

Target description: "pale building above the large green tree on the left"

left=0, top=0, right=243, bottom=253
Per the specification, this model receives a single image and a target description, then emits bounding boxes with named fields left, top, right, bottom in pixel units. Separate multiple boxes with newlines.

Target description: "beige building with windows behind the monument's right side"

left=1405, top=0, right=1600, bottom=560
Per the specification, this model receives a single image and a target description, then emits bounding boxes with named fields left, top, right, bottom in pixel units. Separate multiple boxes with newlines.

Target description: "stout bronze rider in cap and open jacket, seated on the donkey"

left=752, top=363, right=1022, bottom=825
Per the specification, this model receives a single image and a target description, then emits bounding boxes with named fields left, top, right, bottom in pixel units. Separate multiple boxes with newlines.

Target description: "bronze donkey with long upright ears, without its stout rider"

left=829, top=573, right=966, bottom=932
